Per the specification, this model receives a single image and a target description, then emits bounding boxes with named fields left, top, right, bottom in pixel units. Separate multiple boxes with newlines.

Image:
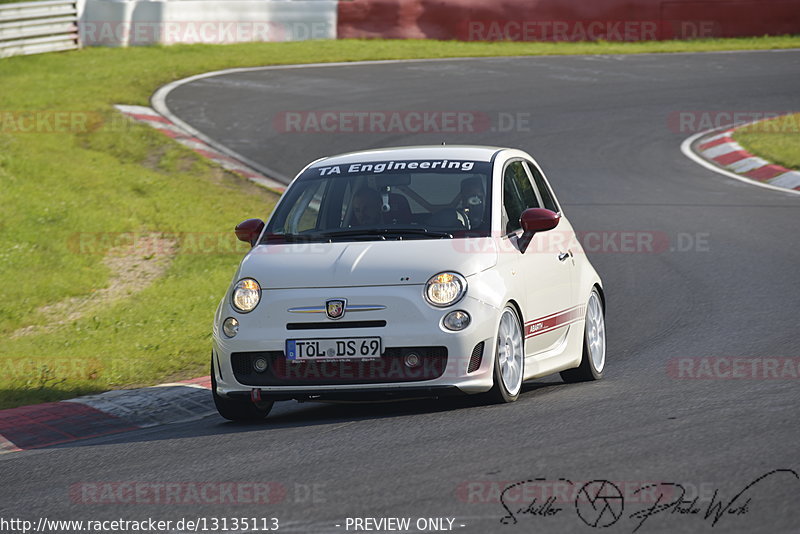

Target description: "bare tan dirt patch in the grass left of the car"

left=11, top=234, right=178, bottom=339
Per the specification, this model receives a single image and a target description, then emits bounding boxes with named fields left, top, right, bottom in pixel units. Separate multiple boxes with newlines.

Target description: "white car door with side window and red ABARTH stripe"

left=501, top=159, right=579, bottom=356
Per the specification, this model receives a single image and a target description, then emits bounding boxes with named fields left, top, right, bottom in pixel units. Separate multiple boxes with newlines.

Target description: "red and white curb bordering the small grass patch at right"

left=681, top=121, right=800, bottom=194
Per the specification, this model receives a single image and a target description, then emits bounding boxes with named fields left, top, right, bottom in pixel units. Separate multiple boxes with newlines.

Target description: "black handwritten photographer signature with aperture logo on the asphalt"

left=500, top=469, right=800, bottom=532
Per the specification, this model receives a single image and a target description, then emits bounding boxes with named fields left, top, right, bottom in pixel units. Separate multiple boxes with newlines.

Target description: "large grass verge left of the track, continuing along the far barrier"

left=0, top=37, right=800, bottom=408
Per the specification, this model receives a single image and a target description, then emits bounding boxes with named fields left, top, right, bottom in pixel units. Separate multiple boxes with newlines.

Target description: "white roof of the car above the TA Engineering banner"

left=311, top=145, right=505, bottom=167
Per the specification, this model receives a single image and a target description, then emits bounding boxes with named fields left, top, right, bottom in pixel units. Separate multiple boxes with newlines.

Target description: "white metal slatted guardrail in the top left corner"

left=0, top=0, right=80, bottom=58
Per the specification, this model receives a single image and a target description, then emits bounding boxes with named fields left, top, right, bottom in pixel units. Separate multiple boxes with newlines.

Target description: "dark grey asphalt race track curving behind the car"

left=0, top=51, right=800, bottom=533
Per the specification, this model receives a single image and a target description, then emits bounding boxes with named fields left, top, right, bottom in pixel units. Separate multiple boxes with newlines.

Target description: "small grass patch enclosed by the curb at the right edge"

left=733, top=113, right=800, bottom=170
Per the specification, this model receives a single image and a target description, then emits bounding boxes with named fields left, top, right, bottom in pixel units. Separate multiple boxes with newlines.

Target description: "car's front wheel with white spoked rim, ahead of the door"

left=487, top=304, right=525, bottom=404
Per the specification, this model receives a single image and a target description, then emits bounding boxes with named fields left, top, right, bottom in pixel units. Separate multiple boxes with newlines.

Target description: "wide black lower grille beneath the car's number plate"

left=231, top=347, right=447, bottom=386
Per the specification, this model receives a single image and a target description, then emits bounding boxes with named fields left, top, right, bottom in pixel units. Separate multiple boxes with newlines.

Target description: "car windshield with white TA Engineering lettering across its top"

left=264, top=160, right=491, bottom=242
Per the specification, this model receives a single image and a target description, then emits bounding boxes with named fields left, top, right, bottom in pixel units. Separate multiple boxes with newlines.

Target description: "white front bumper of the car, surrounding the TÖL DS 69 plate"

left=213, top=285, right=500, bottom=400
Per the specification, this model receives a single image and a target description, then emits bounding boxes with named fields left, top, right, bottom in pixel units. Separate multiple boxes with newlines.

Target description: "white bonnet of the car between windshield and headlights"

left=238, top=238, right=497, bottom=289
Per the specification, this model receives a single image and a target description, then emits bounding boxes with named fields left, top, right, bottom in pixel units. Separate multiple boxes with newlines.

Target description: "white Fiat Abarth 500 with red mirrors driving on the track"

left=211, top=146, right=606, bottom=420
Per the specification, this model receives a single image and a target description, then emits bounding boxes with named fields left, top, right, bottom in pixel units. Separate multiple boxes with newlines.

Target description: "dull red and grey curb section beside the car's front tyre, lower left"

left=0, top=376, right=216, bottom=454
